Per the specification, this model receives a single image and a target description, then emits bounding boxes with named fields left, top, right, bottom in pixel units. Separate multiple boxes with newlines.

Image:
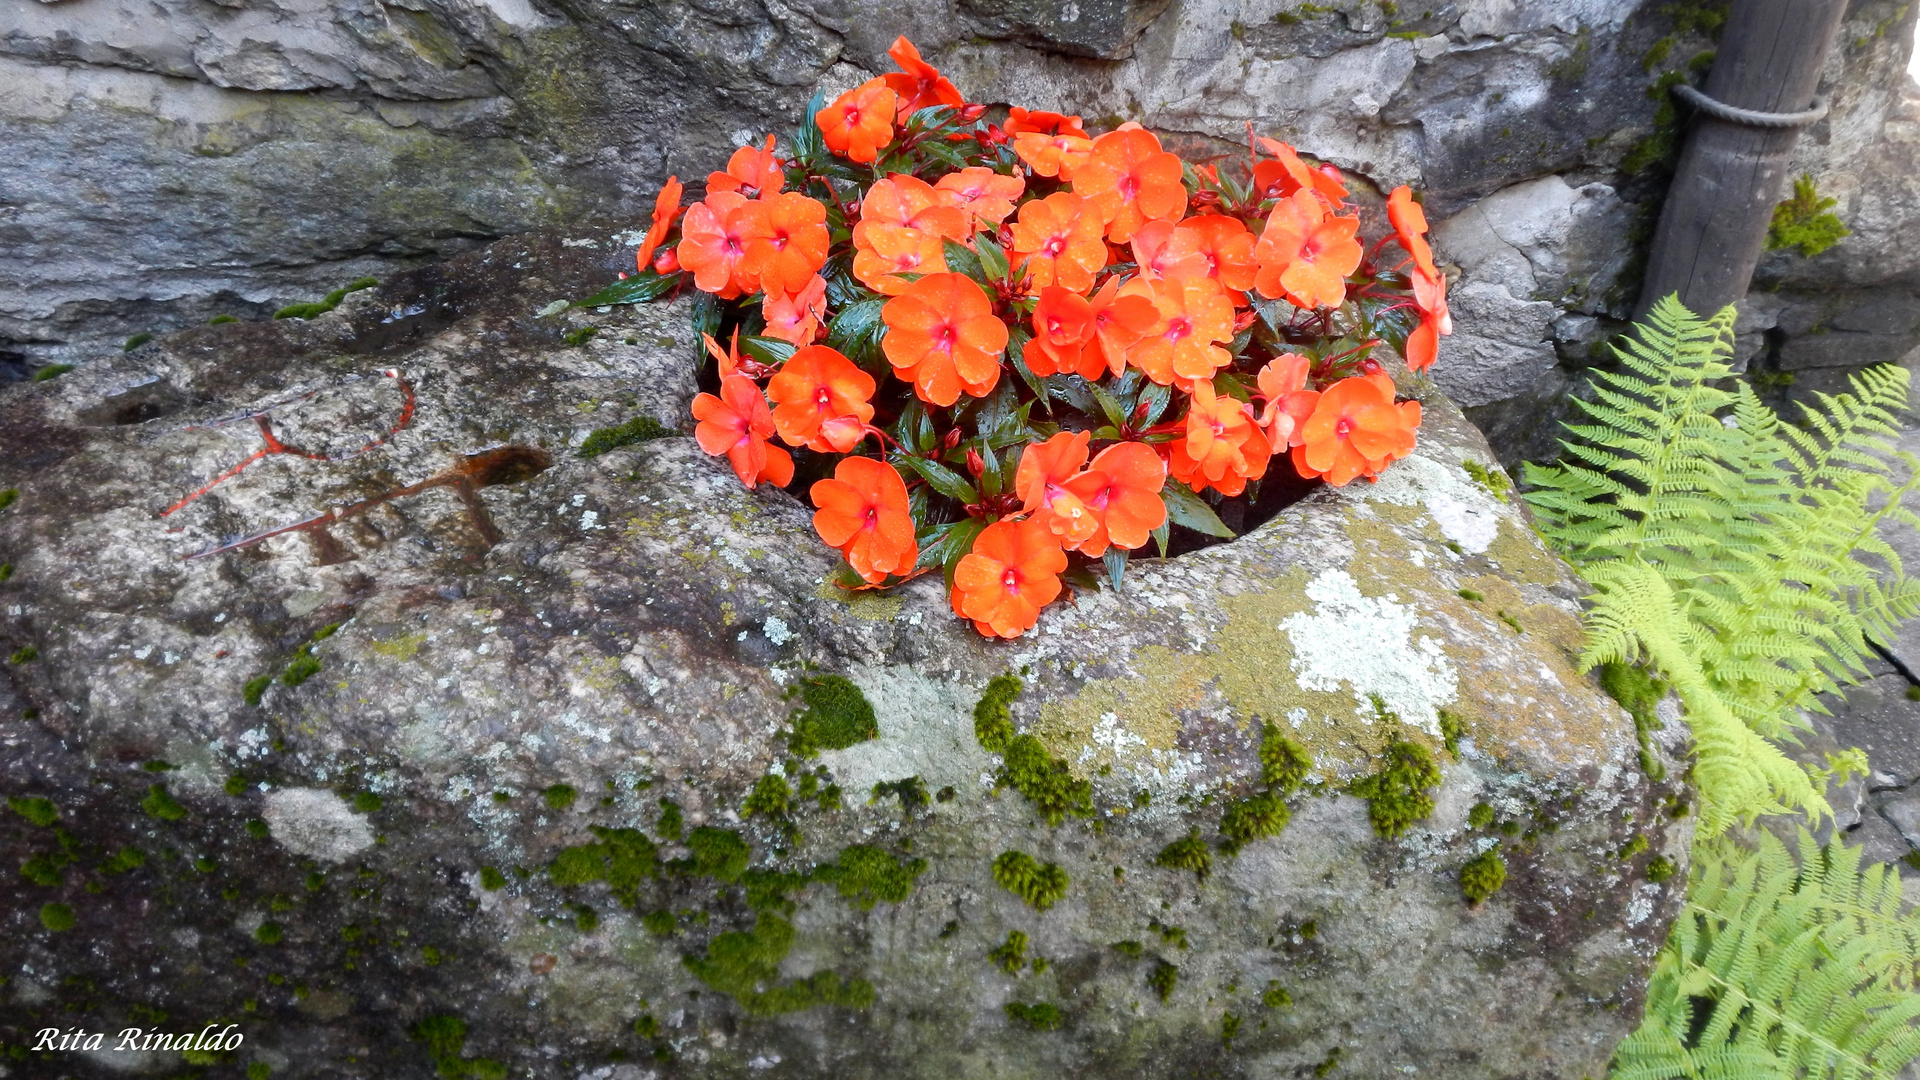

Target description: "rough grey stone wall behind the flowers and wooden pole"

left=0, top=0, right=1920, bottom=463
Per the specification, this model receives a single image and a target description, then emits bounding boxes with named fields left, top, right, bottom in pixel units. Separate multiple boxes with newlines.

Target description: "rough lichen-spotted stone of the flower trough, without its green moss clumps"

left=0, top=234, right=1692, bottom=1080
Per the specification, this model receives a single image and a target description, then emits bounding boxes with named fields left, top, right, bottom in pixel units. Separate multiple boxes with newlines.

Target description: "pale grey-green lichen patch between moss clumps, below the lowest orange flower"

left=820, top=667, right=995, bottom=798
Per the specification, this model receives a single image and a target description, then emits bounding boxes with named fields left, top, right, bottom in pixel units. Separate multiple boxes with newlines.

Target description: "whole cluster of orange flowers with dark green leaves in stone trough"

left=614, top=38, right=1452, bottom=638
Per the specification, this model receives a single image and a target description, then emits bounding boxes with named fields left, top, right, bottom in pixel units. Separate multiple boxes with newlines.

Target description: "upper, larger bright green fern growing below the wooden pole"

left=1526, top=298, right=1920, bottom=836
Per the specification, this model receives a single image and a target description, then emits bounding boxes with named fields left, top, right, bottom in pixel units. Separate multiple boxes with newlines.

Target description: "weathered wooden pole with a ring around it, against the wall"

left=1638, top=0, right=1847, bottom=315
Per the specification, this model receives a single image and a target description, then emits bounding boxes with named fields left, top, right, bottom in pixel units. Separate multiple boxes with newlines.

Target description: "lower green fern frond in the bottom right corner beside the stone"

left=1609, top=830, right=1920, bottom=1080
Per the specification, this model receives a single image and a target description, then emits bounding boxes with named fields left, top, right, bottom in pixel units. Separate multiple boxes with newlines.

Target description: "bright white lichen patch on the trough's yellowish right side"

left=1281, top=571, right=1459, bottom=738
